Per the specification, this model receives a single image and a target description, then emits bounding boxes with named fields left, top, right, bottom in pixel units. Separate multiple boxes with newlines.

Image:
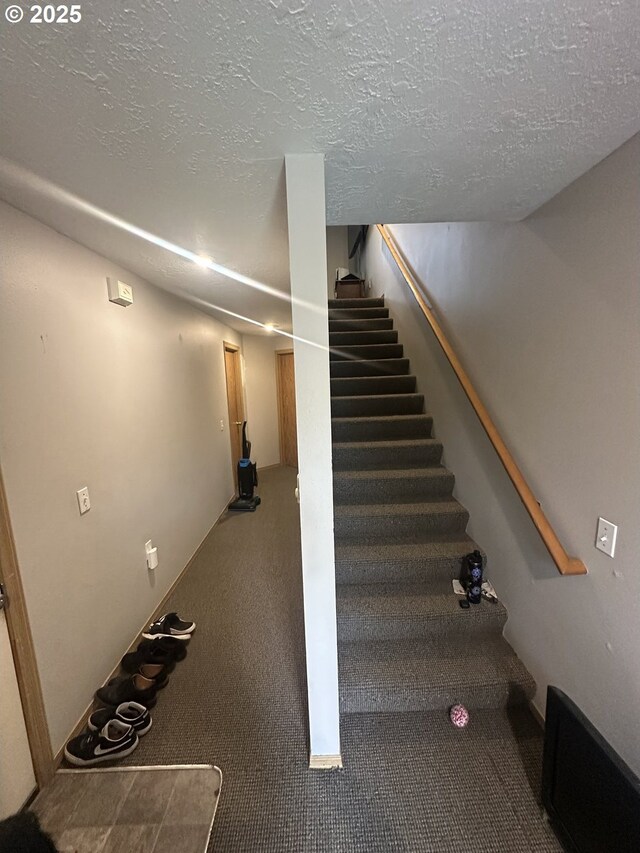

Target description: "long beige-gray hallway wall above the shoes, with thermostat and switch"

left=0, top=204, right=240, bottom=750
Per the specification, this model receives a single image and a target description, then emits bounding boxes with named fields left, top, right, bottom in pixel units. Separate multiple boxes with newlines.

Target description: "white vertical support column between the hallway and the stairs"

left=285, top=154, right=342, bottom=768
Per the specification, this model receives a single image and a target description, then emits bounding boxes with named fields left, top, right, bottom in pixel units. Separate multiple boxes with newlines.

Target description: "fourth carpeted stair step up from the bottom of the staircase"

left=334, top=500, right=469, bottom=544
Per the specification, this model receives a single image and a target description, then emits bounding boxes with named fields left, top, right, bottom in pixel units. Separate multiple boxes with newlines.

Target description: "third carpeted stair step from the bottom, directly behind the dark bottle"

left=335, top=533, right=477, bottom=584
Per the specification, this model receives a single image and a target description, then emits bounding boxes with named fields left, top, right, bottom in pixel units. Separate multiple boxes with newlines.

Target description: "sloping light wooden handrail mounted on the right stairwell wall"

left=376, top=225, right=587, bottom=575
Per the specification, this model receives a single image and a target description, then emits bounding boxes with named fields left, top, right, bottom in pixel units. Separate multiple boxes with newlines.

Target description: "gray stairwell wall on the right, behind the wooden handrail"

left=366, top=137, right=640, bottom=772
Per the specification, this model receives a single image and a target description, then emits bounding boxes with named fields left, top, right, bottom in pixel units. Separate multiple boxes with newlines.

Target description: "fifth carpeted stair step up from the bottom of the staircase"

left=333, top=467, right=455, bottom=504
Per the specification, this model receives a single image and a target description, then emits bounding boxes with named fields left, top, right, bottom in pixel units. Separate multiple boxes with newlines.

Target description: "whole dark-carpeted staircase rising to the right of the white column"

left=329, top=299, right=535, bottom=714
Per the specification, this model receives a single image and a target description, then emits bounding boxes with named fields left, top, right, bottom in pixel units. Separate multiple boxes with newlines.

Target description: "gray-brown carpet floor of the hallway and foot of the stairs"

left=120, top=468, right=561, bottom=853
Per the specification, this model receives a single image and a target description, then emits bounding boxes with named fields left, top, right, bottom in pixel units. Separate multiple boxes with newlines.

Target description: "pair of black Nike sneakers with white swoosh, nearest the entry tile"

left=64, top=702, right=152, bottom=767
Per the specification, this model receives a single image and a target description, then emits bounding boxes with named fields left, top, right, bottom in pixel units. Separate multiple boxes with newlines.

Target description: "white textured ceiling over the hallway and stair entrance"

left=0, top=0, right=640, bottom=330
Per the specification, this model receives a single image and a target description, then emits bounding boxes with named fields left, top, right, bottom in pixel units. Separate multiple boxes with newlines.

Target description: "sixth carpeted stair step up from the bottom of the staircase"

left=333, top=438, right=442, bottom=471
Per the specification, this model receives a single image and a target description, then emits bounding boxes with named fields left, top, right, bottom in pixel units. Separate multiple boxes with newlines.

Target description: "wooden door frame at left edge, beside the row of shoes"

left=0, top=467, right=53, bottom=788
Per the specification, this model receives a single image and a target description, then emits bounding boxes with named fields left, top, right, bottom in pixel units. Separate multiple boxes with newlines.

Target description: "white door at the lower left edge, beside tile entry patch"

left=0, top=611, right=36, bottom=820
